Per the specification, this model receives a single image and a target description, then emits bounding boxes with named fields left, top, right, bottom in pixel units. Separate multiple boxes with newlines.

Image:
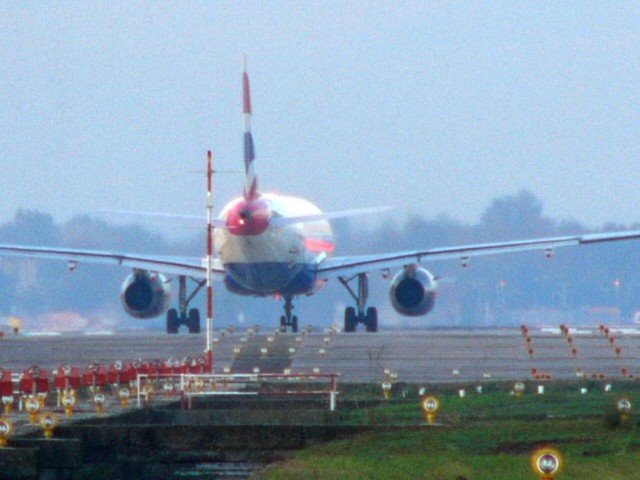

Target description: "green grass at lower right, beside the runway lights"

left=252, top=384, right=640, bottom=480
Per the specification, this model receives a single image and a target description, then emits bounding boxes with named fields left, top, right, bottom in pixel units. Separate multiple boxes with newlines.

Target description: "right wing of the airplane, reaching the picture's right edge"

left=317, top=230, right=640, bottom=278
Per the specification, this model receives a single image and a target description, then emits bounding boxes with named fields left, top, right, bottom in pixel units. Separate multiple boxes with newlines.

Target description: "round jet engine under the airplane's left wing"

left=120, top=270, right=171, bottom=318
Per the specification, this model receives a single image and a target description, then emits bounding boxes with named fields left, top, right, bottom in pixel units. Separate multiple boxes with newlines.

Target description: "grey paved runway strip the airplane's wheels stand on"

left=0, top=328, right=640, bottom=383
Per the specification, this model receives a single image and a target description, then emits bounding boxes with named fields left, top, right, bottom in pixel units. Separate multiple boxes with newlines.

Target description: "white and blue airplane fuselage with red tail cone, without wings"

left=215, top=194, right=334, bottom=296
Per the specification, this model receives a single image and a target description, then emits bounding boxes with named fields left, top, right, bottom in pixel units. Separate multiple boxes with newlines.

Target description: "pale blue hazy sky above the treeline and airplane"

left=0, top=1, right=640, bottom=231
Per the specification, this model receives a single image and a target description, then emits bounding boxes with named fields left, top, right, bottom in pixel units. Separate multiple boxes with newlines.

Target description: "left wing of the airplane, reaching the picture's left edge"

left=0, top=244, right=224, bottom=278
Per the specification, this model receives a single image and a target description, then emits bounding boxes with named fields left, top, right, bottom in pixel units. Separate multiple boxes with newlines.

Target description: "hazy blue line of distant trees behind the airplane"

left=0, top=191, right=640, bottom=328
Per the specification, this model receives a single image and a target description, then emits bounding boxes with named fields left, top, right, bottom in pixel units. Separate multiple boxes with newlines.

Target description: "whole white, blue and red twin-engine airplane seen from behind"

left=0, top=58, right=640, bottom=334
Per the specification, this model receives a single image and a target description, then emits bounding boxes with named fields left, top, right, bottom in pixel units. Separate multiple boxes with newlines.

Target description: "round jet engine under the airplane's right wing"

left=389, top=265, right=438, bottom=317
